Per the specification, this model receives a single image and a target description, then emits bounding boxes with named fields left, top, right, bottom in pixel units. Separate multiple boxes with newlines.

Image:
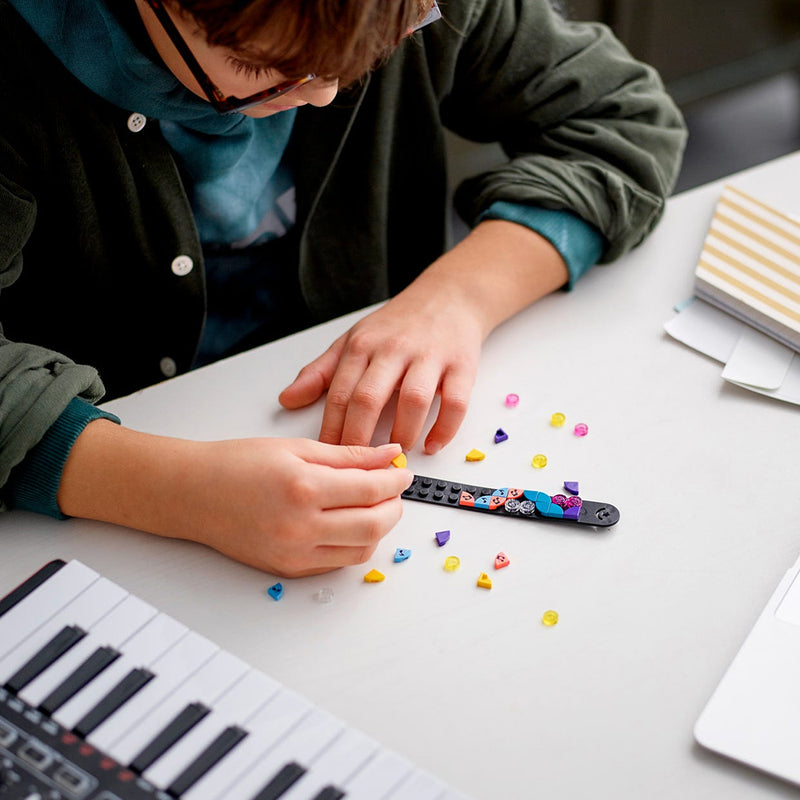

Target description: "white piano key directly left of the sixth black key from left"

left=219, top=708, right=344, bottom=800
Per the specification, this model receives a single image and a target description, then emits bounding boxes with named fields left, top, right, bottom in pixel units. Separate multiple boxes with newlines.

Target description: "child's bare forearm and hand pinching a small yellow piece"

left=58, top=420, right=412, bottom=577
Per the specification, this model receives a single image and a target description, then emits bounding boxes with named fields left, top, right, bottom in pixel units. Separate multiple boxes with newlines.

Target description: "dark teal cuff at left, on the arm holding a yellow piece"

left=6, top=397, right=120, bottom=519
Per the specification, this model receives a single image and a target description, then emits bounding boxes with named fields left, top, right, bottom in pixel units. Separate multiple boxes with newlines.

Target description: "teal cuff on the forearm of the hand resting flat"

left=478, top=200, right=607, bottom=289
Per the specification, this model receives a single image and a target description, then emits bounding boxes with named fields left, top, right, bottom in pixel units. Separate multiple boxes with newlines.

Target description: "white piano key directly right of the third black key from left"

left=88, top=631, right=219, bottom=757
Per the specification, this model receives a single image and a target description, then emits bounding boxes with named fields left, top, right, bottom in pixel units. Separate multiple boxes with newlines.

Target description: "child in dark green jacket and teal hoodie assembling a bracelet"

left=0, top=0, right=685, bottom=575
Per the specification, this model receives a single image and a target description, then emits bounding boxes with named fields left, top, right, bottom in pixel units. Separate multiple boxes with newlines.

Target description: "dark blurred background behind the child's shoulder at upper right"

left=562, top=0, right=800, bottom=191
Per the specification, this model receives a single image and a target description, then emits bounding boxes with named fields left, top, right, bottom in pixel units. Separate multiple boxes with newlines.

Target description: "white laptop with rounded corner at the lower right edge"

left=694, top=559, right=800, bottom=784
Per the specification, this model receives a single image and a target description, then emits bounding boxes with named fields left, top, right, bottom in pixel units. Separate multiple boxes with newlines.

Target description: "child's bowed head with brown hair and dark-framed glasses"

left=137, top=0, right=434, bottom=116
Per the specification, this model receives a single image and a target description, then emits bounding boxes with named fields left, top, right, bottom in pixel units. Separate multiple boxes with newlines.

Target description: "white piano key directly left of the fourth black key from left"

left=107, top=650, right=247, bottom=764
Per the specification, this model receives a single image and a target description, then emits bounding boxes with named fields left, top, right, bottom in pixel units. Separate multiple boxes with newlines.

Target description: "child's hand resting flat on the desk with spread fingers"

left=280, top=278, right=484, bottom=453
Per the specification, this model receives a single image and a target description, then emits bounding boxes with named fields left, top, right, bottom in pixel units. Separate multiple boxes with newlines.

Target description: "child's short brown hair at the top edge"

left=168, top=0, right=433, bottom=85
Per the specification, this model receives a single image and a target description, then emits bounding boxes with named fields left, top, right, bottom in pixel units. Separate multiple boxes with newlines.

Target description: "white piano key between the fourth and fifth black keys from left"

left=144, top=669, right=280, bottom=787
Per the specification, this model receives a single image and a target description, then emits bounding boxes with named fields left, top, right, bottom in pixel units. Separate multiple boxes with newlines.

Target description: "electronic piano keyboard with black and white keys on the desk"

left=0, top=561, right=465, bottom=800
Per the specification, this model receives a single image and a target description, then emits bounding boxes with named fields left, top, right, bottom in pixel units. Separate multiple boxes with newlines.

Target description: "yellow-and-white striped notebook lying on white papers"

left=695, top=186, right=800, bottom=351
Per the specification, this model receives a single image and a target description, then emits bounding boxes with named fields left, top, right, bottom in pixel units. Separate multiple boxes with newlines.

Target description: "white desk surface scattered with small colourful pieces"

left=0, top=155, right=800, bottom=800
